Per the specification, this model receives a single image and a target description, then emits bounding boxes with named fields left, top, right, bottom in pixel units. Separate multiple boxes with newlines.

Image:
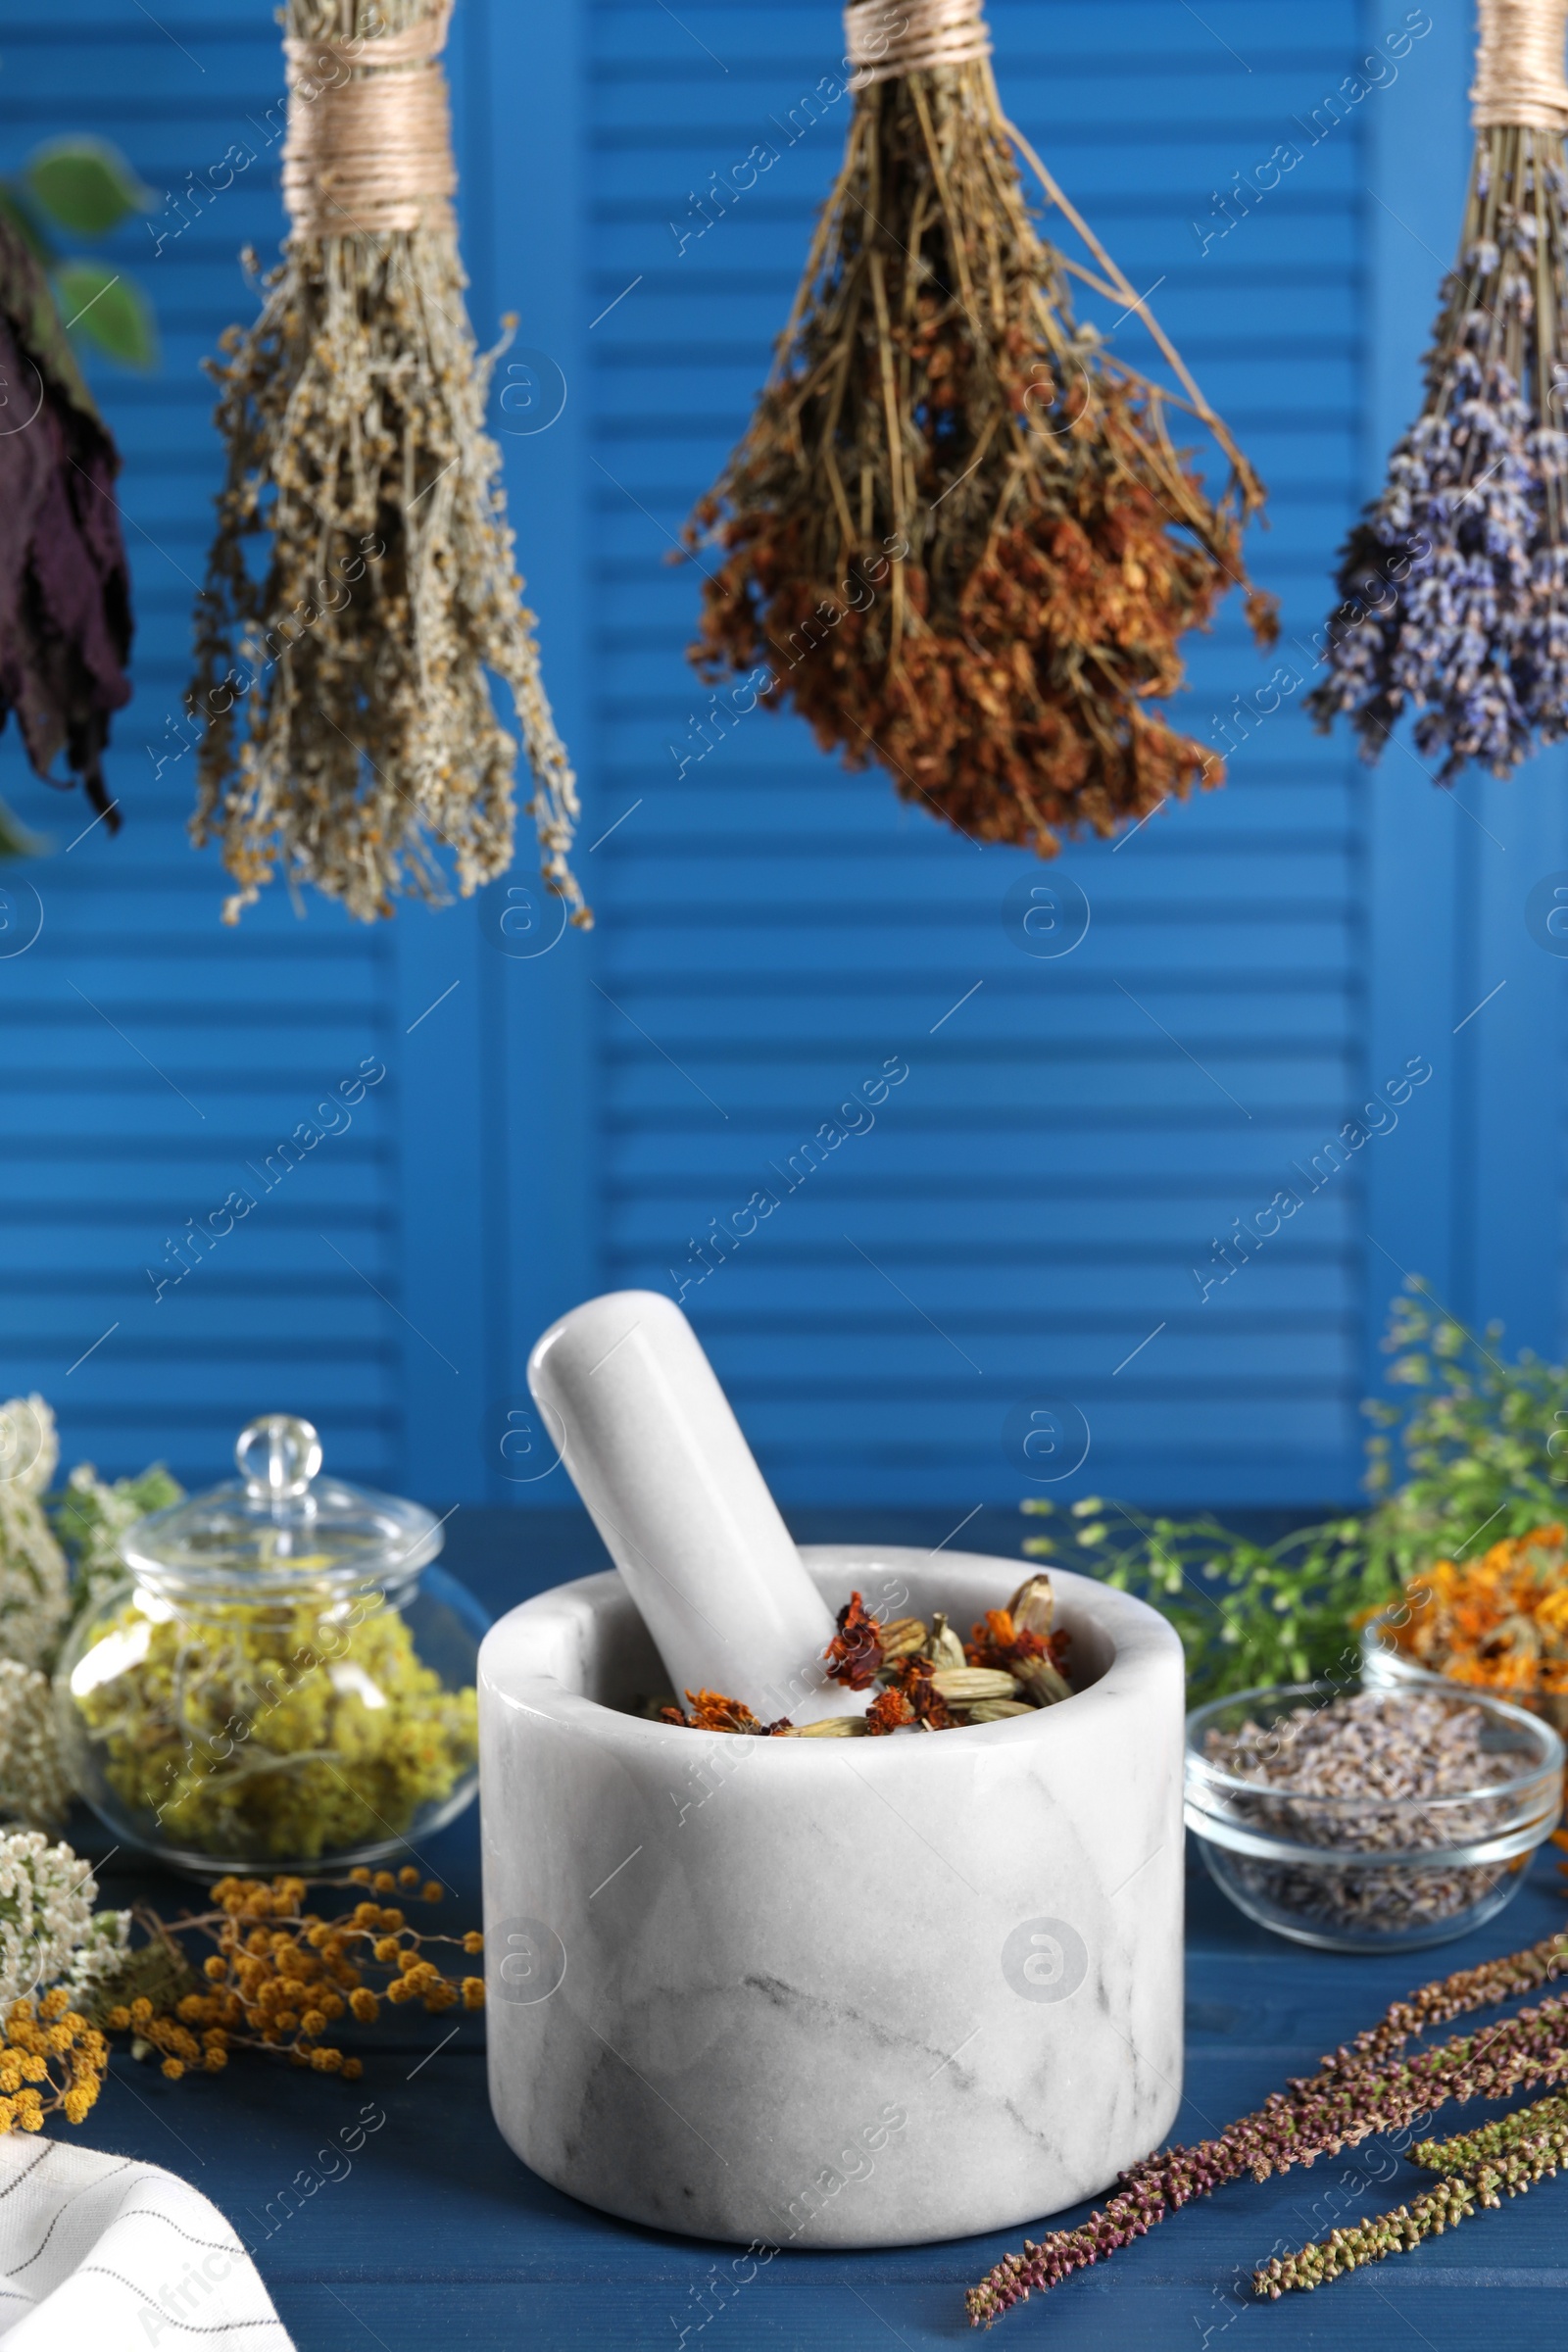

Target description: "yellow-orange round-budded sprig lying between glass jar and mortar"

left=104, top=1863, right=484, bottom=2082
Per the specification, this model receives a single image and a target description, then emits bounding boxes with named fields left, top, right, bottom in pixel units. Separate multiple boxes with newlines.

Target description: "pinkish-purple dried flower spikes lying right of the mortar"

left=966, top=1936, right=1568, bottom=2327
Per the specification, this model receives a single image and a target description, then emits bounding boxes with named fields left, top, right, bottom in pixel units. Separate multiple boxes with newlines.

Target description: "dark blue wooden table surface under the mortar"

left=70, top=1512, right=1568, bottom=2352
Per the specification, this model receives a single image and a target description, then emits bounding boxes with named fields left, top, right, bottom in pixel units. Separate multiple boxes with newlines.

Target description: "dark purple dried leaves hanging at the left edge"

left=0, top=212, right=131, bottom=854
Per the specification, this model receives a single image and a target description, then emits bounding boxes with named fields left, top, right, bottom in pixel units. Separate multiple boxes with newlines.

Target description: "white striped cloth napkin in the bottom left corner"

left=0, top=2131, right=291, bottom=2352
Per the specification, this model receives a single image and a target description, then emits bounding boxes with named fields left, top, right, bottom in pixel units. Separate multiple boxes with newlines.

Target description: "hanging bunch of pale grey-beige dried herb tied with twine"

left=188, top=0, right=590, bottom=924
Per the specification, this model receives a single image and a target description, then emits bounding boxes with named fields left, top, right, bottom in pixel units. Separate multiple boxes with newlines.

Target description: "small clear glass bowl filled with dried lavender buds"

left=1187, top=1677, right=1563, bottom=1952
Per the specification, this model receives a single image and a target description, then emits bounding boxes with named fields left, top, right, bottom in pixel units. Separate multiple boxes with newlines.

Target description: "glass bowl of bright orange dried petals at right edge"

left=1361, top=1527, right=1568, bottom=1736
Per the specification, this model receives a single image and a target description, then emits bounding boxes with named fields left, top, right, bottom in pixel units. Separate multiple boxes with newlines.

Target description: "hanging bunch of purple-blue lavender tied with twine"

left=1307, top=0, right=1568, bottom=783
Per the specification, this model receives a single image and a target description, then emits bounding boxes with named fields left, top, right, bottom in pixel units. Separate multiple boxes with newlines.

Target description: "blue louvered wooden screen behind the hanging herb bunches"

left=0, top=0, right=1568, bottom=1519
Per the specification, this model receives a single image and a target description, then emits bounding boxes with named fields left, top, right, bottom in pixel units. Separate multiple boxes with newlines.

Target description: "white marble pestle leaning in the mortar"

left=529, top=1292, right=865, bottom=1724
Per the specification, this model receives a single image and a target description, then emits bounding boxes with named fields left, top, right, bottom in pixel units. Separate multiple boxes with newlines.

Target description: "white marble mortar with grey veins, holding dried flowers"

left=479, top=1545, right=1183, bottom=2246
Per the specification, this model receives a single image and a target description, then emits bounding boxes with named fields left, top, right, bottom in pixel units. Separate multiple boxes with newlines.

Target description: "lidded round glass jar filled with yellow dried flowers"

left=54, top=1413, right=487, bottom=1875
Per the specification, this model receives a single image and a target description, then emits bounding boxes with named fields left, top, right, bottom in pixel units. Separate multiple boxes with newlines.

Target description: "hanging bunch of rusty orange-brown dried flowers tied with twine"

left=686, top=0, right=1274, bottom=857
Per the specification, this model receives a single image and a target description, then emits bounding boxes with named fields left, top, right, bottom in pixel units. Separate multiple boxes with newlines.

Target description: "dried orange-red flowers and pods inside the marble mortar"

left=661, top=1576, right=1072, bottom=1740
